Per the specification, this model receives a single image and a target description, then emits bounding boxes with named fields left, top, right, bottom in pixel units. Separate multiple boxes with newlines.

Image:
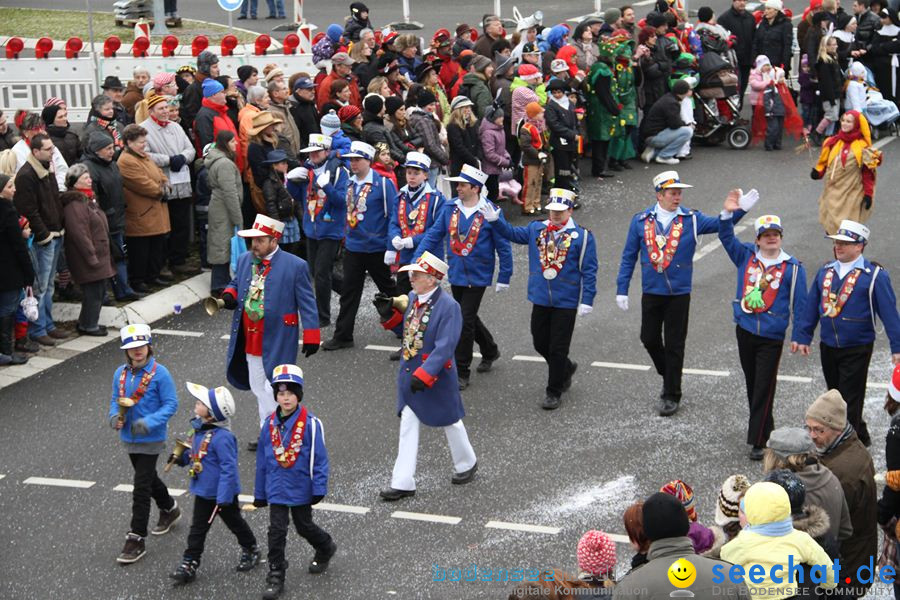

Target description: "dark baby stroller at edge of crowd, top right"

left=694, top=52, right=750, bottom=150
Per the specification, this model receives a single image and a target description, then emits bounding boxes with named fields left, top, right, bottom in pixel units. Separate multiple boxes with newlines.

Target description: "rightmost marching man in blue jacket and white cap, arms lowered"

left=791, top=219, right=900, bottom=446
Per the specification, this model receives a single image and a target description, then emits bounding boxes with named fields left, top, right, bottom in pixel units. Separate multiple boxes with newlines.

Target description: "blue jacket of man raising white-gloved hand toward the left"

left=493, top=214, right=597, bottom=308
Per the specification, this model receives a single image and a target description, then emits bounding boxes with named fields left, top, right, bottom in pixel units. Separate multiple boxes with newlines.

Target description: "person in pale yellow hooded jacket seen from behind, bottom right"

left=722, top=481, right=836, bottom=600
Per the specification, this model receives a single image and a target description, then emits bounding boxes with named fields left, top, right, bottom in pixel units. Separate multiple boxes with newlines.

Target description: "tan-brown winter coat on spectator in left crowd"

left=119, top=148, right=171, bottom=237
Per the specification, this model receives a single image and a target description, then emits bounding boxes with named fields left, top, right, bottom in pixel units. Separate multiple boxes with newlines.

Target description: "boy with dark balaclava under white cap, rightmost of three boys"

left=253, top=365, right=337, bottom=600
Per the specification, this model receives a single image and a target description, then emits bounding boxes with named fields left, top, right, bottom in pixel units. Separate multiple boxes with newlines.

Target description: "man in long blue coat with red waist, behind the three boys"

left=222, top=215, right=321, bottom=450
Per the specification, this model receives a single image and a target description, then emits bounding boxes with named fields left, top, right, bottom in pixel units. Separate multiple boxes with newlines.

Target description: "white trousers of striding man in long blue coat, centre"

left=391, top=406, right=476, bottom=490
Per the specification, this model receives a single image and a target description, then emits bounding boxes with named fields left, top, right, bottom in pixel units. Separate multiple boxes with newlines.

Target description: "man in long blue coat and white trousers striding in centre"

left=374, top=252, right=478, bottom=502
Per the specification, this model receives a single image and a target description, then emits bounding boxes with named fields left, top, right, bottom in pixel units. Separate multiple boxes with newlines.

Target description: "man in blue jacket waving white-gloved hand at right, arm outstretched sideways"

left=616, top=171, right=759, bottom=417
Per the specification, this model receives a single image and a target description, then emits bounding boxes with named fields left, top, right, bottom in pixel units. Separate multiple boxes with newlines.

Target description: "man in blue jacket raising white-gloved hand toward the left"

left=482, top=188, right=597, bottom=410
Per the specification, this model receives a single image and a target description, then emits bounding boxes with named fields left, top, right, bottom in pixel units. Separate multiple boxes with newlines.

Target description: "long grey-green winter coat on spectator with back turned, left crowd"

left=203, top=147, right=244, bottom=265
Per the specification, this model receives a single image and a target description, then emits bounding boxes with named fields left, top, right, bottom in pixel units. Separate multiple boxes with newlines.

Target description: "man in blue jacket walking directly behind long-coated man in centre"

left=415, top=165, right=512, bottom=390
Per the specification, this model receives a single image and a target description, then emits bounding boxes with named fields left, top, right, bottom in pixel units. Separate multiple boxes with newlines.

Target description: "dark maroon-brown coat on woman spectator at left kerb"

left=60, top=190, right=116, bottom=285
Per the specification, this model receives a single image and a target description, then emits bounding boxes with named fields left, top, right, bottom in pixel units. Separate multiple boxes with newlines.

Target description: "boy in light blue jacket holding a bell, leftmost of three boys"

left=107, top=324, right=181, bottom=564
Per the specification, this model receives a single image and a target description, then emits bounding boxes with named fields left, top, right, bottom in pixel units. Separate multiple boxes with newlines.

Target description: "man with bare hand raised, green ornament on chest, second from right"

left=719, top=204, right=806, bottom=460
